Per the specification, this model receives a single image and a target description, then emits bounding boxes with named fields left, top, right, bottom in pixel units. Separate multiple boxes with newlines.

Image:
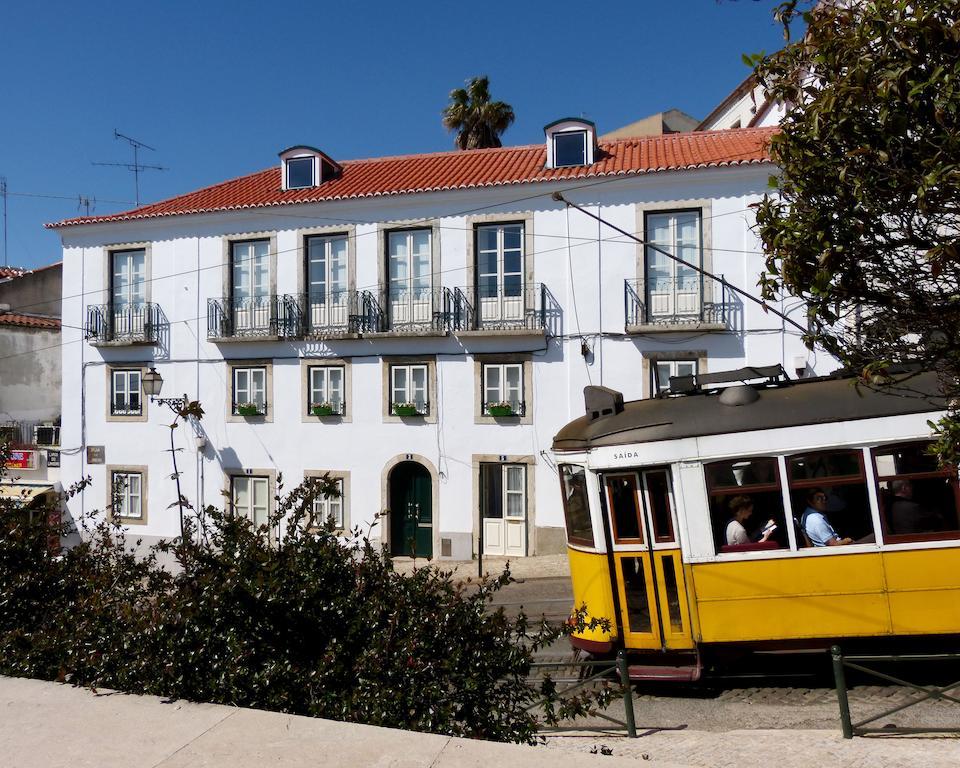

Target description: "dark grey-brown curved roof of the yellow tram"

left=553, top=373, right=946, bottom=451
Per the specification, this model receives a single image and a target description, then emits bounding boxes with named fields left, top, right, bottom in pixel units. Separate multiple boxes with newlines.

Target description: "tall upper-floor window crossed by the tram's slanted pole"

left=644, top=211, right=702, bottom=321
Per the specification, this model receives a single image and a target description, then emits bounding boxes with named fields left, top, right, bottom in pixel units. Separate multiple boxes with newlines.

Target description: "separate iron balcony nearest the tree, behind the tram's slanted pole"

left=623, top=275, right=733, bottom=333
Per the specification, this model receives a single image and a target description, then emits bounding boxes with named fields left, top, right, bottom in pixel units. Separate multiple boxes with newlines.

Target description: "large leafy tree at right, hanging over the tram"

left=757, top=0, right=960, bottom=460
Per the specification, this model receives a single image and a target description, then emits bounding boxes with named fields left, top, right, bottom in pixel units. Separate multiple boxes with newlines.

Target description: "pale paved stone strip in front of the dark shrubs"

left=0, top=677, right=668, bottom=768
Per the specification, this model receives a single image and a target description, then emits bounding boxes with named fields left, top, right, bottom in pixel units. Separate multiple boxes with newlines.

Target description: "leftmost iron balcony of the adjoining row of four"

left=207, top=294, right=303, bottom=341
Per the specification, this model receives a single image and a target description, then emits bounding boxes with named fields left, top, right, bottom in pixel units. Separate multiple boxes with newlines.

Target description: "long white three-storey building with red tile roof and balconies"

left=51, top=119, right=830, bottom=559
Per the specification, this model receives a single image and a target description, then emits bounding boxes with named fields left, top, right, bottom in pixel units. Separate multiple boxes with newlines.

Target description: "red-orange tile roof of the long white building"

left=47, top=128, right=776, bottom=228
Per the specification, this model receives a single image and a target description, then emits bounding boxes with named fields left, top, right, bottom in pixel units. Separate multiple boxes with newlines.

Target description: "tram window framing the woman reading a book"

left=704, top=457, right=789, bottom=552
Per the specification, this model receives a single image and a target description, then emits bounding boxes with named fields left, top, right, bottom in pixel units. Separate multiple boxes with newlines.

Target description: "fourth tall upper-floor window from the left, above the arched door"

left=387, top=229, right=433, bottom=327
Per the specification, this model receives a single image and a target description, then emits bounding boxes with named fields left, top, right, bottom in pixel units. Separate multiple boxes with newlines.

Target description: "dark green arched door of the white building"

left=388, top=461, right=433, bottom=558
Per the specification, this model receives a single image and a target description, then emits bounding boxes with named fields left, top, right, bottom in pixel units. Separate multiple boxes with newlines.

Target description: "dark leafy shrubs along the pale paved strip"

left=0, top=448, right=612, bottom=742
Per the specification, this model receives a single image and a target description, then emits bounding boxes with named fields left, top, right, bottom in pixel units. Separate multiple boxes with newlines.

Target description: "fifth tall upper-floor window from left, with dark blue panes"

left=476, top=224, right=525, bottom=323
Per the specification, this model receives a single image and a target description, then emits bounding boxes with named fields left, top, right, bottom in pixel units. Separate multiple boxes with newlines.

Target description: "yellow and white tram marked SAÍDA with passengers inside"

left=553, top=366, right=960, bottom=680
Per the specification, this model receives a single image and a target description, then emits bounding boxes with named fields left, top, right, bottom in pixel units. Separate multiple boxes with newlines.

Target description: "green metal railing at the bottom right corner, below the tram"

left=830, top=645, right=960, bottom=739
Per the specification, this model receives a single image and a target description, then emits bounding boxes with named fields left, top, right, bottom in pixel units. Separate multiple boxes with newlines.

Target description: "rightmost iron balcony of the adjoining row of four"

left=454, top=282, right=560, bottom=336
